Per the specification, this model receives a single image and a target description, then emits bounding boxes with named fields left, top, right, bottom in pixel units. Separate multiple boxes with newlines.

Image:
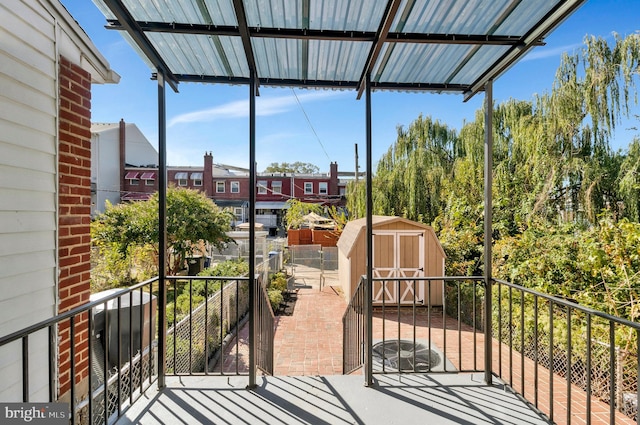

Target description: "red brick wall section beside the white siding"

left=58, top=57, right=91, bottom=395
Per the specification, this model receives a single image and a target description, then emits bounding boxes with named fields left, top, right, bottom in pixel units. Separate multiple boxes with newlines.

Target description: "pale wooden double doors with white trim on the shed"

left=373, top=231, right=425, bottom=304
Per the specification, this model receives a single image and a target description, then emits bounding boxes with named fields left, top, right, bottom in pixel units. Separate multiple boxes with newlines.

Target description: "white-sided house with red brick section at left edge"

left=0, top=0, right=120, bottom=402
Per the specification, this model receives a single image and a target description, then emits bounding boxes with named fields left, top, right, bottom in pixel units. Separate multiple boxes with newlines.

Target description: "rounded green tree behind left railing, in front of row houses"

left=92, top=187, right=232, bottom=275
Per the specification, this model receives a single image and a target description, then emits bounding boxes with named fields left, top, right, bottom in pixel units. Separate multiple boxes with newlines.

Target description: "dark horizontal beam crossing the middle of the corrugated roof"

left=105, top=20, right=528, bottom=46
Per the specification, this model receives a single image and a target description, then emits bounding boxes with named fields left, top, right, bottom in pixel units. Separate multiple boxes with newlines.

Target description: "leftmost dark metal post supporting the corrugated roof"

left=158, top=69, right=167, bottom=389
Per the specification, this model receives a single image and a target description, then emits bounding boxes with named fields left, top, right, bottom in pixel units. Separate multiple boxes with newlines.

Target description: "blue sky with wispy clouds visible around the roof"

left=61, top=0, right=640, bottom=172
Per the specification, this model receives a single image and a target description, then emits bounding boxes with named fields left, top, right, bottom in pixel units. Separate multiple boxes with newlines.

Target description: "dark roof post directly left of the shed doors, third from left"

left=364, top=72, right=373, bottom=387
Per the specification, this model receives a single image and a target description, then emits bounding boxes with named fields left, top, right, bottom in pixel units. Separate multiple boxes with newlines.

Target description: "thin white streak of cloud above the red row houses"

left=169, top=91, right=342, bottom=127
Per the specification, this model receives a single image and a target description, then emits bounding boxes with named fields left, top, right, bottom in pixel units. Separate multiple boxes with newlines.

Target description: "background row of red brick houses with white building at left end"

left=91, top=120, right=353, bottom=235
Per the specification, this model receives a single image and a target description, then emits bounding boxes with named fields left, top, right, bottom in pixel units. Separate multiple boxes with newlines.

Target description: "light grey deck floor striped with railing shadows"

left=117, top=374, right=548, bottom=425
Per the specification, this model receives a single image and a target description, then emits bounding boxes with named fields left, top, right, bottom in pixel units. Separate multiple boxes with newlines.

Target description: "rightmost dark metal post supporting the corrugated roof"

left=484, top=80, right=493, bottom=385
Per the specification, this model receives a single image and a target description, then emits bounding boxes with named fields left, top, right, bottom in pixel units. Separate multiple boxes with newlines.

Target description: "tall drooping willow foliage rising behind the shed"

left=348, top=34, right=640, bottom=230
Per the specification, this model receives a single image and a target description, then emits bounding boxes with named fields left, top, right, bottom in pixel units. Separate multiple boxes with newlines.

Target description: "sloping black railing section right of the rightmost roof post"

left=493, top=281, right=640, bottom=424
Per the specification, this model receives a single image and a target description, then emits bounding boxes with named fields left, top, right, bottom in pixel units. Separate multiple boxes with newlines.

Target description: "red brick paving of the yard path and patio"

left=218, top=286, right=635, bottom=425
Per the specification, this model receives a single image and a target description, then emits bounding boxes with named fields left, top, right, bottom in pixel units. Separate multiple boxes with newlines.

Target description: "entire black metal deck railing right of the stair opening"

left=343, top=277, right=640, bottom=424
